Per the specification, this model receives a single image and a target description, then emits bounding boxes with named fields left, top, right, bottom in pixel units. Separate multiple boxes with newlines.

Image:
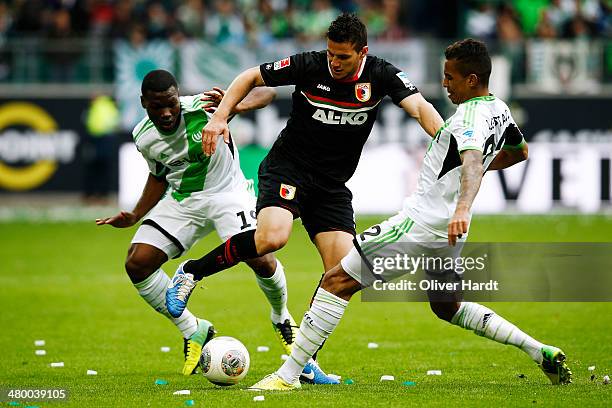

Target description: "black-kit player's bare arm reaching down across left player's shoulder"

left=202, top=67, right=265, bottom=156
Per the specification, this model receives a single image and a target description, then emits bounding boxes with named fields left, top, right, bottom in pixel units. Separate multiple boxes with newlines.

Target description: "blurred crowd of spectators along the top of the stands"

left=0, top=0, right=612, bottom=46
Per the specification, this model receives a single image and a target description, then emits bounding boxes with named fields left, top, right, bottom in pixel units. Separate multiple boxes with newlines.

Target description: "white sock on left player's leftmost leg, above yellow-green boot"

left=134, top=269, right=198, bottom=338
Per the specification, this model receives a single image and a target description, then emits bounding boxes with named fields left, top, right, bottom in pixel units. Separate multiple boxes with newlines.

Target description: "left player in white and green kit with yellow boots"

left=96, top=70, right=296, bottom=375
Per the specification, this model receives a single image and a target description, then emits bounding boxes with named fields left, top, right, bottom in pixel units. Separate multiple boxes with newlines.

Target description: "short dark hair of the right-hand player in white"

left=444, top=38, right=491, bottom=86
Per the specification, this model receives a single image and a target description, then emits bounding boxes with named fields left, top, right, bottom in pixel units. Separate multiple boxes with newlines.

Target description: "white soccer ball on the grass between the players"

left=200, top=336, right=251, bottom=386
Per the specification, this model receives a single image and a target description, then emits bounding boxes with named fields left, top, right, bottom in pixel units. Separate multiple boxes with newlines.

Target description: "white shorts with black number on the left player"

left=132, top=182, right=257, bottom=258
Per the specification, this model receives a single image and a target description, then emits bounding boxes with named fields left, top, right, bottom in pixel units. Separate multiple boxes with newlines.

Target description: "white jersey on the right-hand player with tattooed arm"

left=403, top=96, right=523, bottom=237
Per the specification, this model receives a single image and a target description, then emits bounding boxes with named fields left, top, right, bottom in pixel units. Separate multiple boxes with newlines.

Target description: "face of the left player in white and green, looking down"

left=140, top=86, right=181, bottom=132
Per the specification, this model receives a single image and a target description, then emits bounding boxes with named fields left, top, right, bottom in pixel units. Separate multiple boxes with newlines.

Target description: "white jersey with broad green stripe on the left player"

left=132, top=95, right=245, bottom=201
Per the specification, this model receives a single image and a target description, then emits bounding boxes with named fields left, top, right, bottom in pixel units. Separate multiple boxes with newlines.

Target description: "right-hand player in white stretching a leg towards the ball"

left=250, top=39, right=572, bottom=391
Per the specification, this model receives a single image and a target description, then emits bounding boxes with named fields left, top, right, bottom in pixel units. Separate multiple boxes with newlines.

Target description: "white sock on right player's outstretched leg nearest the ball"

left=276, top=288, right=348, bottom=384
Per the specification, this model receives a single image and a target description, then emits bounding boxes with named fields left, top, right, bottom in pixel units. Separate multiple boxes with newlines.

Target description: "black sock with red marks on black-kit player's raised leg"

left=183, top=230, right=259, bottom=280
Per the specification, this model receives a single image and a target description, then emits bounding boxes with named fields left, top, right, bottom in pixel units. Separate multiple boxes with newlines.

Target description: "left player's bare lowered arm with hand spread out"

left=96, top=173, right=168, bottom=228
